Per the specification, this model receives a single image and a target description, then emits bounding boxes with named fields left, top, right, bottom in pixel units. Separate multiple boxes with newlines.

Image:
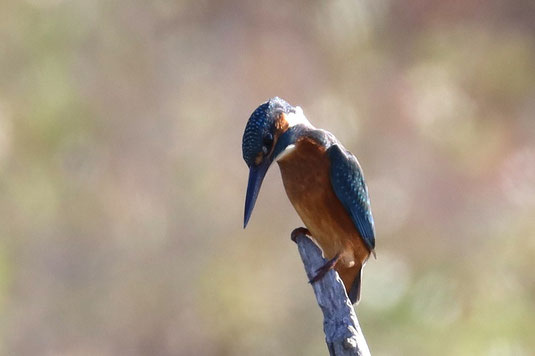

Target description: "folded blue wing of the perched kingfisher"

left=327, top=144, right=375, bottom=251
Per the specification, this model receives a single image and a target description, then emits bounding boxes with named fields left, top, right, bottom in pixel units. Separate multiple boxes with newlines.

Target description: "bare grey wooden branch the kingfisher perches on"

left=295, top=233, right=370, bottom=356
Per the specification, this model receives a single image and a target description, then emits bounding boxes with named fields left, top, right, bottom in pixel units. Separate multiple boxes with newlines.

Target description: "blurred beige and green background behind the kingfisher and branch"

left=0, top=0, right=535, bottom=355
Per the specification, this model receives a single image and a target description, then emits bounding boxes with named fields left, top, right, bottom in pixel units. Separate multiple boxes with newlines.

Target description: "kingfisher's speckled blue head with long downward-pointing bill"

left=242, top=97, right=310, bottom=227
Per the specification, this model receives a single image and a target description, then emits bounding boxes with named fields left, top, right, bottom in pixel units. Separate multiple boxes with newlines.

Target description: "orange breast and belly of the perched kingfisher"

left=278, top=138, right=369, bottom=270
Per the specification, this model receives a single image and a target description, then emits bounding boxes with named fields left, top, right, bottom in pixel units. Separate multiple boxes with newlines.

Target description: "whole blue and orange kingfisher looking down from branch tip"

left=242, top=97, right=375, bottom=304
